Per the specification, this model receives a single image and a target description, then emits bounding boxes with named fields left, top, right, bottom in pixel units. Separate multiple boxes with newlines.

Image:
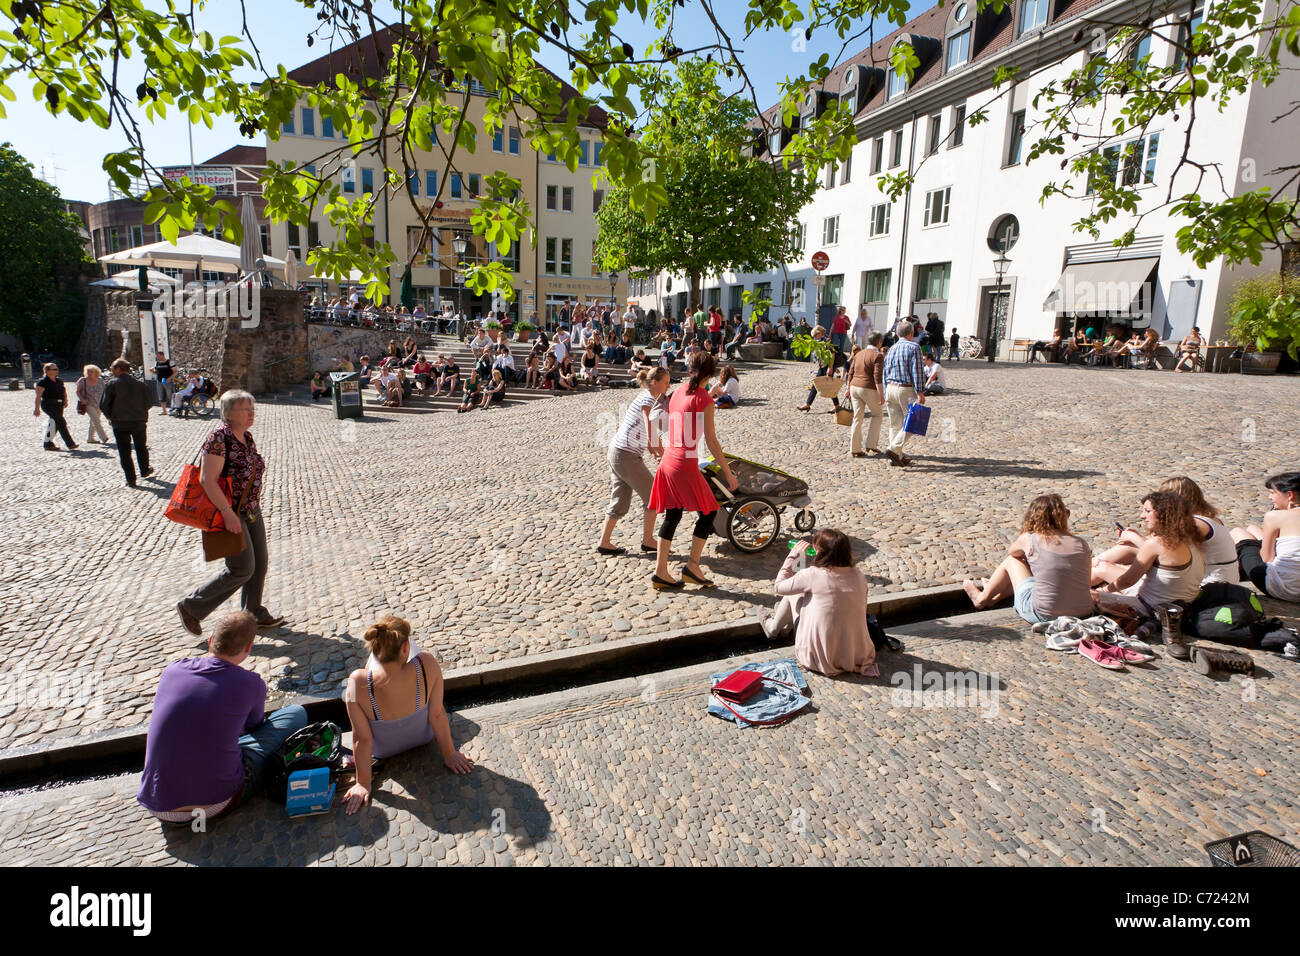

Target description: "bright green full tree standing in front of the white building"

left=595, top=59, right=816, bottom=312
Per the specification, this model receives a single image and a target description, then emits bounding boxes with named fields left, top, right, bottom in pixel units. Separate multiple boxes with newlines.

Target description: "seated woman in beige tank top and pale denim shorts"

left=962, top=494, right=1093, bottom=624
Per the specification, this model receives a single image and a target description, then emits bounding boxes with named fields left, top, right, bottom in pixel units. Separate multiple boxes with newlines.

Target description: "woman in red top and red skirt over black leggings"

left=650, top=351, right=738, bottom=589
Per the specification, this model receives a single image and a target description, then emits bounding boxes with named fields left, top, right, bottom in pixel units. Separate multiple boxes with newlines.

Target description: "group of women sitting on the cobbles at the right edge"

left=962, top=472, right=1300, bottom=623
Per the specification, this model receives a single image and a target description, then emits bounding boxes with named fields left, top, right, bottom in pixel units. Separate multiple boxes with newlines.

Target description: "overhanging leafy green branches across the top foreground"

left=0, top=0, right=1300, bottom=300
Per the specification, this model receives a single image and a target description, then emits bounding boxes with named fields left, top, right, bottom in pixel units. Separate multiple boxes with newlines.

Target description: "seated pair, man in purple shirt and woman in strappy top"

left=135, top=611, right=473, bottom=826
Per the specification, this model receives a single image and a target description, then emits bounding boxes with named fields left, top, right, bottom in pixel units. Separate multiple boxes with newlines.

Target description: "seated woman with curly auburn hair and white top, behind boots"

left=1092, top=492, right=1205, bottom=614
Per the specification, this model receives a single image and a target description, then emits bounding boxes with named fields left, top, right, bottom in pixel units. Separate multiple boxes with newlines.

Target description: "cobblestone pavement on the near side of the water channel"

left=0, top=611, right=1300, bottom=866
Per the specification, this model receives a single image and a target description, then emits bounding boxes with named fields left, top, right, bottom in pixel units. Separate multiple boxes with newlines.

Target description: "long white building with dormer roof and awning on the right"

left=655, top=0, right=1300, bottom=354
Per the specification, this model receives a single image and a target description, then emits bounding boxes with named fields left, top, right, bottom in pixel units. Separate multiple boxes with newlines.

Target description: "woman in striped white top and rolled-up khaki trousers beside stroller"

left=595, top=368, right=672, bottom=555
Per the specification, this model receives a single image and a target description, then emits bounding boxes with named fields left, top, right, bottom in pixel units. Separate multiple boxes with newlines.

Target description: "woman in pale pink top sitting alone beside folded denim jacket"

left=759, top=528, right=880, bottom=678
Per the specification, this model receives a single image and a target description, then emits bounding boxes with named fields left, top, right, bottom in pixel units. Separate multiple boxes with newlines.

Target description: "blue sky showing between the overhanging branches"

left=0, top=0, right=904, bottom=202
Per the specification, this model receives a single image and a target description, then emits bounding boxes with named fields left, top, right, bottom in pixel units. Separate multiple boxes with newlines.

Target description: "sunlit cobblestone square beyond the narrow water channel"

left=0, top=363, right=1300, bottom=748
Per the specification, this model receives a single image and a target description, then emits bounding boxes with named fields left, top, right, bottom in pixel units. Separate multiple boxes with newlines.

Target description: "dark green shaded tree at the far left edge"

left=0, top=143, right=86, bottom=351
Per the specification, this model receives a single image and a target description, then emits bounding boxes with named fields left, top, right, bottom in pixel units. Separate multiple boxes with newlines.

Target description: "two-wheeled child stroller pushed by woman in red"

left=699, top=455, right=816, bottom=554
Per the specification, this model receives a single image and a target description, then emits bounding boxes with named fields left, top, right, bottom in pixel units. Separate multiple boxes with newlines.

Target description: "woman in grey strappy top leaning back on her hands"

left=343, top=618, right=475, bottom=814
